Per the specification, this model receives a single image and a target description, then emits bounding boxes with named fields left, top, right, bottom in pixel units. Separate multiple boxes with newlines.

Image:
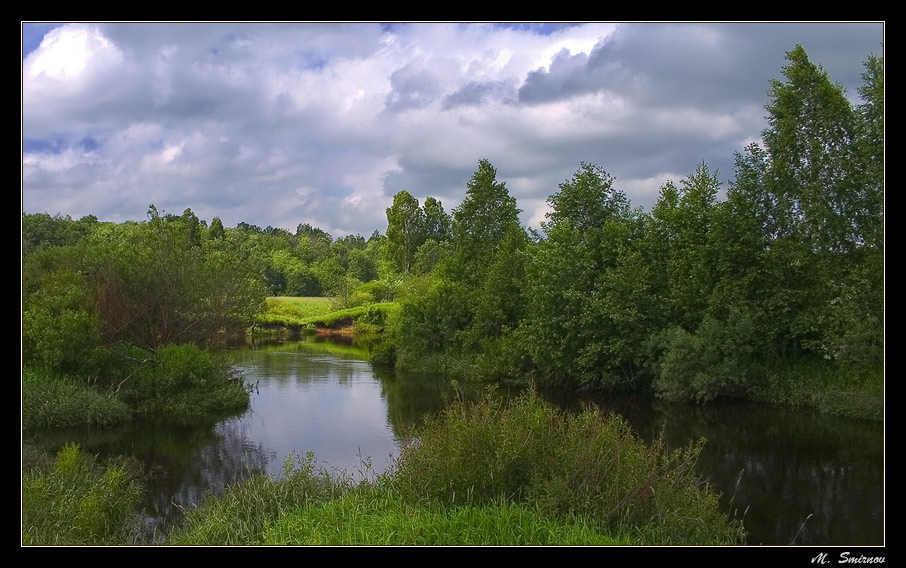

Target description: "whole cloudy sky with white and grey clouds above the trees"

left=21, top=23, right=884, bottom=236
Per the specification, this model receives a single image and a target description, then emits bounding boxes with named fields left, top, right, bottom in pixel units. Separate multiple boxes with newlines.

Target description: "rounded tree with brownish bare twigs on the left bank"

left=91, top=206, right=264, bottom=348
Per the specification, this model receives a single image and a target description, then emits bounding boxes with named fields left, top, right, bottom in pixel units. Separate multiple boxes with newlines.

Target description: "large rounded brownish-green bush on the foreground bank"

left=393, top=392, right=743, bottom=544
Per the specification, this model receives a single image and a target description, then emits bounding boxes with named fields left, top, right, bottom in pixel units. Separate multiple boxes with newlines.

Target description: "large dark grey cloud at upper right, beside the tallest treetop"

left=519, top=24, right=881, bottom=109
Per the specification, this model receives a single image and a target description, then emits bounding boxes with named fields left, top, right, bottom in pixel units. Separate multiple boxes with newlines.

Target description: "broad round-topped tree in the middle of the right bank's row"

left=522, top=163, right=648, bottom=388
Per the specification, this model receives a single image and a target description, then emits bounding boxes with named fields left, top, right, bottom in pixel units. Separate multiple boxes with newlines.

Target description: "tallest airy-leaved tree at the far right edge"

left=710, top=46, right=883, bottom=368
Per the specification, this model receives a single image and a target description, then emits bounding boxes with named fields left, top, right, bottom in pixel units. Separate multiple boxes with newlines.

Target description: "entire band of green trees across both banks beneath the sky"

left=23, top=46, right=884, bottom=408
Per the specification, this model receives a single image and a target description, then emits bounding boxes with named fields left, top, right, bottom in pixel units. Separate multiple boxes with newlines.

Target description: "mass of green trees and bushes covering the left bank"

left=22, top=206, right=264, bottom=429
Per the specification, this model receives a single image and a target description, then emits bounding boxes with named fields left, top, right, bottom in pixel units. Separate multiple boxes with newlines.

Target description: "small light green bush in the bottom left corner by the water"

left=22, top=444, right=141, bottom=545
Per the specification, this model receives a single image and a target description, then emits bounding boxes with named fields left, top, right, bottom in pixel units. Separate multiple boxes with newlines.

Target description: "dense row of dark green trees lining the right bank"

left=380, top=46, right=884, bottom=414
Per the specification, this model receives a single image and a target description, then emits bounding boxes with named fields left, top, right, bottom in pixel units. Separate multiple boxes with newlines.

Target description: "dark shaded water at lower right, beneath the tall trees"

left=550, top=390, right=884, bottom=545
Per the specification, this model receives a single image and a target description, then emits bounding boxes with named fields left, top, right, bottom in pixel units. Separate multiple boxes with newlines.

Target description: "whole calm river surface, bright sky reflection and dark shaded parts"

left=30, top=343, right=884, bottom=545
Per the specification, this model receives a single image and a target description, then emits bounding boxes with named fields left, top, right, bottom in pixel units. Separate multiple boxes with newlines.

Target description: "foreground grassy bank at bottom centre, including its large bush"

left=168, top=393, right=743, bottom=545
